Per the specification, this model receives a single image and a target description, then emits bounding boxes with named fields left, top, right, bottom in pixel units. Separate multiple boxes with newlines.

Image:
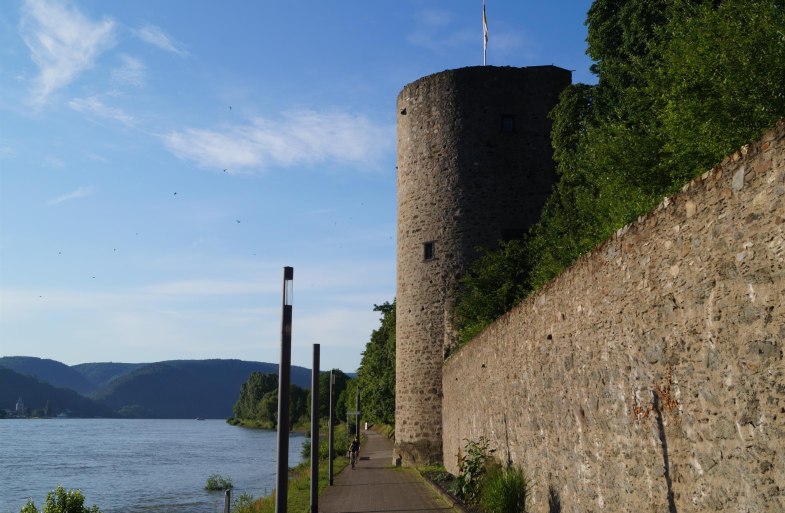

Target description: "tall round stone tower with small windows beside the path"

left=394, top=66, right=571, bottom=465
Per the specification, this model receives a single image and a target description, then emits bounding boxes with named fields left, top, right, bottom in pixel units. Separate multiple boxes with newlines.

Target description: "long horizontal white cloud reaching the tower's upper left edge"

left=163, top=110, right=395, bottom=171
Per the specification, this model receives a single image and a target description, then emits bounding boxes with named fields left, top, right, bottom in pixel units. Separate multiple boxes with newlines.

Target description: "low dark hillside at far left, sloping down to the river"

left=0, top=367, right=116, bottom=417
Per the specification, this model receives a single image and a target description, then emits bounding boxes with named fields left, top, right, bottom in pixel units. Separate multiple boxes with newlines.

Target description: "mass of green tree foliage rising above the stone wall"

left=456, top=0, right=785, bottom=342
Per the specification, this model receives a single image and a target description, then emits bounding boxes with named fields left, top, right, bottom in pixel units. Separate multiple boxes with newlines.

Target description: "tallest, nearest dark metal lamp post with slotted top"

left=275, top=267, right=294, bottom=513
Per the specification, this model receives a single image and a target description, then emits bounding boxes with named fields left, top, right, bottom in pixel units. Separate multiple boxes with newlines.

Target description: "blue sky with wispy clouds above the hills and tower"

left=0, top=0, right=594, bottom=372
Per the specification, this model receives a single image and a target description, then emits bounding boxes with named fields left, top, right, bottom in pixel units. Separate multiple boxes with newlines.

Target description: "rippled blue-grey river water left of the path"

left=0, top=419, right=305, bottom=513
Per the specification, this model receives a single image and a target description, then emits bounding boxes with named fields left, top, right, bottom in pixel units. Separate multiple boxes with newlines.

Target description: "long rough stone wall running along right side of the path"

left=443, top=122, right=785, bottom=513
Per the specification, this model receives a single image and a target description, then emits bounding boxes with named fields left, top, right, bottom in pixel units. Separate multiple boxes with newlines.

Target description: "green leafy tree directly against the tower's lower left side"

left=356, top=301, right=395, bottom=424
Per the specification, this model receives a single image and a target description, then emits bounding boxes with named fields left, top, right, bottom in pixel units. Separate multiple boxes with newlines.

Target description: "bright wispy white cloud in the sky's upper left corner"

left=20, top=0, right=115, bottom=105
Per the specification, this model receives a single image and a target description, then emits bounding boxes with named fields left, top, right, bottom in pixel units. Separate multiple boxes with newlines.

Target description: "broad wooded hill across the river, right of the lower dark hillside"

left=93, top=360, right=311, bottom=418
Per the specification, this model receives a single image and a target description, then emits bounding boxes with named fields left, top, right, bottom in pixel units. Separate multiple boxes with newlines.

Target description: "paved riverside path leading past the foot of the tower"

left=319, top=430, right=457, bottom=513
